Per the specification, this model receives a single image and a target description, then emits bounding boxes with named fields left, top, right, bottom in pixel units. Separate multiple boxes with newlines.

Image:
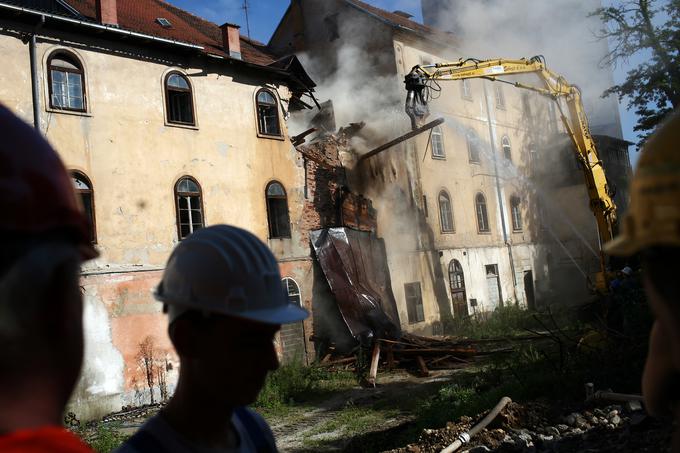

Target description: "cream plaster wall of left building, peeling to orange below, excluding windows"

left=0, top=23, right=312, bottom=419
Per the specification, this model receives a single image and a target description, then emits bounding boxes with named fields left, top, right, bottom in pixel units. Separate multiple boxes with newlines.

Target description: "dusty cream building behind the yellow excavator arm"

left=269, top=0, right=630, bottom=334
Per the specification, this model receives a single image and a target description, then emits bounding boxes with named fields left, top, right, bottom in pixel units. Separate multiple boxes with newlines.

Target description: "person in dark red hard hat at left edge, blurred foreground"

left=0, top=106, right=97, bottom=453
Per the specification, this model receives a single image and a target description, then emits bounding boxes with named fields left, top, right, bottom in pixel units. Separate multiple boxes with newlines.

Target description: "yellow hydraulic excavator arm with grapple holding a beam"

left=404, top=57, right=616, bottom=292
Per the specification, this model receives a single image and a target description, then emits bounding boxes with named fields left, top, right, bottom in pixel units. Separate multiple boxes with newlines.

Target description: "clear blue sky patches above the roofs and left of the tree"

left=169, top=0, right=639, bottom=165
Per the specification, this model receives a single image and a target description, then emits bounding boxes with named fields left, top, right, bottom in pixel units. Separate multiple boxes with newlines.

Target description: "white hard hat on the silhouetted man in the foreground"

left=154, top=225, right=308, bottom=324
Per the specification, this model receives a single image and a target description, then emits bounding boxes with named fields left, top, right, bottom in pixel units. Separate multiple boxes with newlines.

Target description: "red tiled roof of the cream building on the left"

left=65, top=0, right=277, bottom=66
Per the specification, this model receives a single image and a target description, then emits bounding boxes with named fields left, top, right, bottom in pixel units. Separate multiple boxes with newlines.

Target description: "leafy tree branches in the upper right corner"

left=592, top=0, right=680, bottom=142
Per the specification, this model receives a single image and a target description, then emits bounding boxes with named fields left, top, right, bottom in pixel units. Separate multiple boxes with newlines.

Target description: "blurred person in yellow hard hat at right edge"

left=605, top=108, right=680, bottom=452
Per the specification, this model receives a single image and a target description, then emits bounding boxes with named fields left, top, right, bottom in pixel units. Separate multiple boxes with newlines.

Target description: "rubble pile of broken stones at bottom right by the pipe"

left=390, top=402, right=672, bottom=453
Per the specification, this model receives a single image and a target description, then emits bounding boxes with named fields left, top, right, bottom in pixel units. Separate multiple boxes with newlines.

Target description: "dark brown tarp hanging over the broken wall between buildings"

left=310, top=228, right=401, bottom=343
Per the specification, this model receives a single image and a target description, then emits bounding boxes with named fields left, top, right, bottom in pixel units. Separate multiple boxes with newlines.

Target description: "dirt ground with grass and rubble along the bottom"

left=75, top=369, right=671, bottom=453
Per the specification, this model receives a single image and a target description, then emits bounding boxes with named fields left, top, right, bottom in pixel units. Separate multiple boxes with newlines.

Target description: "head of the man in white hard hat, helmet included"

left=155, top=225, right=307, bottom=406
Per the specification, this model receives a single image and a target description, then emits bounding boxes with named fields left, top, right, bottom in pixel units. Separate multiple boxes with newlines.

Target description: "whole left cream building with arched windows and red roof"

left=0, top=0, right=313, bottom=419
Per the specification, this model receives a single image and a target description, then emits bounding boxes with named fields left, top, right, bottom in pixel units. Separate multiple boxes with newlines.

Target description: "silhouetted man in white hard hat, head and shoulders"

left=118, top=225, right=308, bottom=453
